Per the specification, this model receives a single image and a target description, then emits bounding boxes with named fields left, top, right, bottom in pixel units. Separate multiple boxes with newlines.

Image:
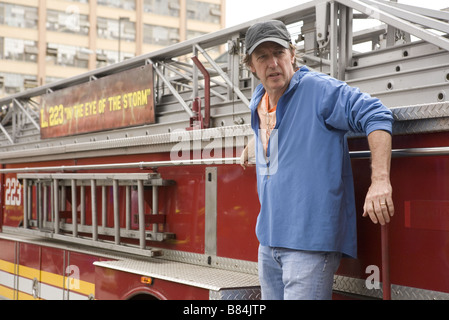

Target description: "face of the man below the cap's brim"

left=250, top=42, right=295, bottom=94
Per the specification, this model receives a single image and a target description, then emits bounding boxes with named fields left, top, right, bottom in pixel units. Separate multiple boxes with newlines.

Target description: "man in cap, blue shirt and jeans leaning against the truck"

left=241, top=21, right=394, bottom=299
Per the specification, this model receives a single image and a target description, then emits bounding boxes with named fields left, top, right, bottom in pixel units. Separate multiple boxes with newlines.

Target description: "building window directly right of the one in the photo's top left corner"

left=47, top=6, right=89, bottom=35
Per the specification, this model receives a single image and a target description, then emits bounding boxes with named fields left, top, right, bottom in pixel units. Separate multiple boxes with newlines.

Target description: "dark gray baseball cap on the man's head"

left=245, top=20, right=291, bottom=54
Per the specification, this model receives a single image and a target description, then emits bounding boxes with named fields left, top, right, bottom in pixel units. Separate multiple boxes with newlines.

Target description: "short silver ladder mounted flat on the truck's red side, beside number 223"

left=14, top=173, right=175, bottom=256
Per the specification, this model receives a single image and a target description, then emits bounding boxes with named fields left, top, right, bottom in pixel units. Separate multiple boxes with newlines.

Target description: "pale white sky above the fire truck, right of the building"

left=226, top=0, right=449, bottom=27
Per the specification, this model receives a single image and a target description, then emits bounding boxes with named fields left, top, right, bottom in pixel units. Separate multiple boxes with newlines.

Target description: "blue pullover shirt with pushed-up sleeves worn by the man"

left=250, top=67, right=393, bottom=257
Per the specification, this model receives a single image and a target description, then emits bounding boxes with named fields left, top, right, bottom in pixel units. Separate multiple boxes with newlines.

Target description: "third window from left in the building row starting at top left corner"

left=97, top=17, right=136, bottom=41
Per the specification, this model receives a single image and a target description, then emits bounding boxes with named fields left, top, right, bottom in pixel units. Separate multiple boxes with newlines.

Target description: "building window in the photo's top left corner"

left=0, top=3, right=38, bottom=29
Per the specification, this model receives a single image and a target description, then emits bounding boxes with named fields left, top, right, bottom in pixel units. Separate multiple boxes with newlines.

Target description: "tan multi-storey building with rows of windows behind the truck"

left=0, top=0, right=226, bottom=96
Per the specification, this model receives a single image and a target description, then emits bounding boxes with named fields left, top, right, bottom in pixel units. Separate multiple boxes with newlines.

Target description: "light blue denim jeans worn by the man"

left=258, top=245, right=341, bottom=300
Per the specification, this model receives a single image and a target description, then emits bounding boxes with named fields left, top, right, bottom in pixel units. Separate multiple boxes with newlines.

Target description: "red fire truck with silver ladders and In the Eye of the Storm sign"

left=0, top=0, right=449, bottom=300
